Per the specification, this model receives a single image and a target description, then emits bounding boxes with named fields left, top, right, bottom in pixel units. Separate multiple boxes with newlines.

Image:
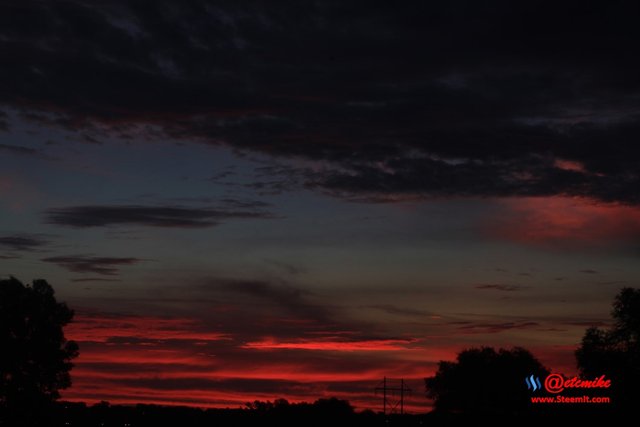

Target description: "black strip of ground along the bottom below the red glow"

left=33, top=402, right=621, bottom=427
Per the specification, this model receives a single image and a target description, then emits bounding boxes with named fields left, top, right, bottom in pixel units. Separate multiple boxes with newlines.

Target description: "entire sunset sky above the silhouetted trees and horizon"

left=0, top=0, right=640, bottom=412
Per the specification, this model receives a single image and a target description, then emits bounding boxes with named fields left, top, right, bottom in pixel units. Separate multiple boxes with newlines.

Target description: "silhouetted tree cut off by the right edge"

left=576, top=288, right=640, bottom=410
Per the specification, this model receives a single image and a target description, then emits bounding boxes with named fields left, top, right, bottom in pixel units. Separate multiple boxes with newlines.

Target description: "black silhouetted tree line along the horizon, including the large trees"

left=0, top=277, right=640, bottom=427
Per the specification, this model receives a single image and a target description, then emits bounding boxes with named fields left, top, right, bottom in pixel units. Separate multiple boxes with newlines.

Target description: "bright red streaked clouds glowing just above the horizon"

left=63, top=313, right=572, bottom=412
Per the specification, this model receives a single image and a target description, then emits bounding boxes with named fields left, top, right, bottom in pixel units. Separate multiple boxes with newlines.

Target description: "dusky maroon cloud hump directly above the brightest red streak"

left=176, top=276, right=384, bottom=342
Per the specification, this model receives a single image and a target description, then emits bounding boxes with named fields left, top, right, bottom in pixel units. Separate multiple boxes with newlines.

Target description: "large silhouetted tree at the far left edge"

left=0, top=277, right=78, bottom=426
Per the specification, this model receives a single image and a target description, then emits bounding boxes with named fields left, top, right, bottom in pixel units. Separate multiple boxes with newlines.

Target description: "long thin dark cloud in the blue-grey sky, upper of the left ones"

left=45, top=205, right=273, bottom=228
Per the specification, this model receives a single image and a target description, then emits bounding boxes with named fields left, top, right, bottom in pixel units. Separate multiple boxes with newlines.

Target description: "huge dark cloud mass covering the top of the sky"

left=0, top=0, right=640, bottom=203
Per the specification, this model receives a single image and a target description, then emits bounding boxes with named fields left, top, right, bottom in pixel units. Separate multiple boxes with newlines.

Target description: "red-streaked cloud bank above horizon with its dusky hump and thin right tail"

left=55, top=277, right=597, bottom=411
